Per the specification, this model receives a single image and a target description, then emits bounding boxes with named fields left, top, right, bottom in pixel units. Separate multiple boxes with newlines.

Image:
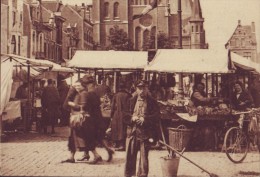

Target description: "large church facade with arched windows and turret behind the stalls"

left=93, top=0, right=208, bottom=50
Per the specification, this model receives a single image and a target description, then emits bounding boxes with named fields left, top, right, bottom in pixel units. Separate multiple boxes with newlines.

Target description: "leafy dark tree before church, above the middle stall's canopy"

left=107, top=25, right=133, bottom=51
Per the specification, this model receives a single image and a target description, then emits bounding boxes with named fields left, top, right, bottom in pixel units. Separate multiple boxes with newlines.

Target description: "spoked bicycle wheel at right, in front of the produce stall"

left=224, top=127, right=249, bottom=163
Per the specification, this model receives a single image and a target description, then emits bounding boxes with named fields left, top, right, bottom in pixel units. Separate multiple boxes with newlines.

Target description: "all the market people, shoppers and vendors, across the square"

left=14, top=74, right=260, bottom=176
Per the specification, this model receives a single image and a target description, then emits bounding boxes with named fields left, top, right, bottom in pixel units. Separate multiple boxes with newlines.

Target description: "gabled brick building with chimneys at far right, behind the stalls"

left=225, top=20, right=259, bottom=62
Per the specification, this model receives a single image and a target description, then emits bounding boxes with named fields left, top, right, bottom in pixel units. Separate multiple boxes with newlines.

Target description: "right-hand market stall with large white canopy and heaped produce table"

left=145, top=49, right=257, bottom=150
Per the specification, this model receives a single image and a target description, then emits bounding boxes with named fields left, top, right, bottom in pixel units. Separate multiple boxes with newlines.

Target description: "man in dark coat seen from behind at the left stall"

left=41, top=79, right=60, bottom=133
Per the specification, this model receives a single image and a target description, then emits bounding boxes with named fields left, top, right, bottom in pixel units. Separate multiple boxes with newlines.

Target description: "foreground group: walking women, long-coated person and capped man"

left=56, top=75, right=160, bottom=176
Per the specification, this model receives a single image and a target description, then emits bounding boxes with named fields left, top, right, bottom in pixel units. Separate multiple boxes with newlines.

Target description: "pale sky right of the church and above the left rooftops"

left=55, top=0, right=260, bottom=52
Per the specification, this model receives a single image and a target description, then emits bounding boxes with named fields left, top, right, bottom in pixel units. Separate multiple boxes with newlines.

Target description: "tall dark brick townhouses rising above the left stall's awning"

left=23, top=0, right=65, bottom=63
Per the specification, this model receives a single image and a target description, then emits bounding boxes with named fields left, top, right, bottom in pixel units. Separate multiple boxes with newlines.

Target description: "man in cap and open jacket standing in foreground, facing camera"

left=125, top=80, right=160, bottom=177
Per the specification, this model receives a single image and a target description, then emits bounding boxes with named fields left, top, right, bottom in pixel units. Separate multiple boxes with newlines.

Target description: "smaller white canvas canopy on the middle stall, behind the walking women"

left=67, top=50, right=148, bottom=70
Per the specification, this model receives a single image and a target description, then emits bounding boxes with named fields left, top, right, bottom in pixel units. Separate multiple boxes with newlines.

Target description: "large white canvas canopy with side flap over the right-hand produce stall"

left=145, top=49, right=255, bottom=73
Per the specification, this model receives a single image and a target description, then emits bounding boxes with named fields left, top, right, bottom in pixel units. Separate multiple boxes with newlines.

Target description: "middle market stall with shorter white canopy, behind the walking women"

left=67, top=50, right=148, bottom=117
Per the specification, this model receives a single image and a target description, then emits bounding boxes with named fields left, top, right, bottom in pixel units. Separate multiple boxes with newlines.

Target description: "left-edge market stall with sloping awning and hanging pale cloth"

left=1, top=54, right=74, bottom=131
